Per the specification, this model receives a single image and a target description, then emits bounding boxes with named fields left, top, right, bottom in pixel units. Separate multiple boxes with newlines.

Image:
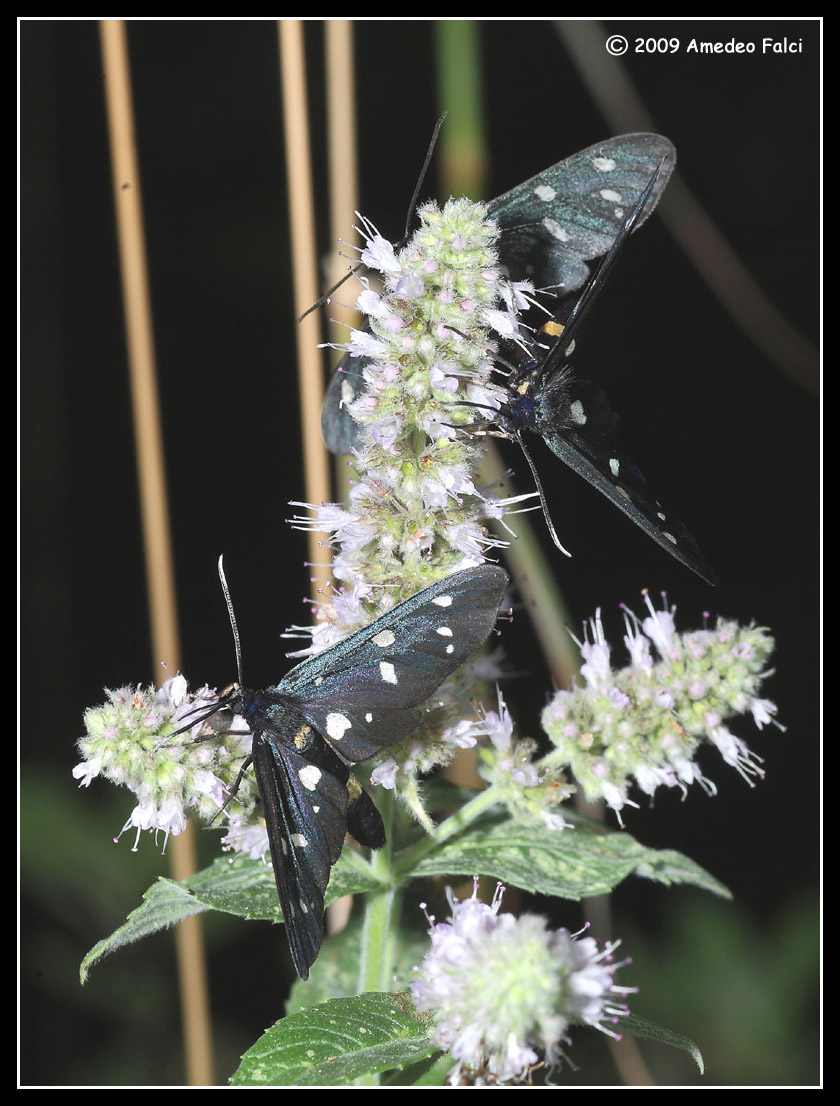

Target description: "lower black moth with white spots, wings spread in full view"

left=215, top=561, right=508, bottom=979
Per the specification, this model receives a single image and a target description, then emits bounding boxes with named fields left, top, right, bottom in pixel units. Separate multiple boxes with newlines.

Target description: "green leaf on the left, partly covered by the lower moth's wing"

left=80, top=849, right=378, bottom=983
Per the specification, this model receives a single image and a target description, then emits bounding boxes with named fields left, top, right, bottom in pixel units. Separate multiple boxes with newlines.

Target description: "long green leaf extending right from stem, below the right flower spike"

left=409, top=812, right=732, bottom=899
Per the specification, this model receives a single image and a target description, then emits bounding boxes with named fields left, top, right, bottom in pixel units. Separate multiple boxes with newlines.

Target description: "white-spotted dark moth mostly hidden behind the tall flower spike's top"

left=321, top=132, right=676, bottom=453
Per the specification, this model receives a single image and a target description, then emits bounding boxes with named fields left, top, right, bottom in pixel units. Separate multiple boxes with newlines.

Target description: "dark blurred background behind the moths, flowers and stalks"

left=19, top=20, right=821, bottom=1086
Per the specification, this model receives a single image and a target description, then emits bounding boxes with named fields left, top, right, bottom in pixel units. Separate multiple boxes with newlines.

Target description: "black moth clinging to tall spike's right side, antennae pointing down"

left=491, top=163, right=717, bottom=584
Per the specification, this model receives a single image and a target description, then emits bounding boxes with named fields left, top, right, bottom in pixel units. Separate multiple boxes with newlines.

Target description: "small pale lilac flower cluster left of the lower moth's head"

left=73, top=675, right=257, bottom=852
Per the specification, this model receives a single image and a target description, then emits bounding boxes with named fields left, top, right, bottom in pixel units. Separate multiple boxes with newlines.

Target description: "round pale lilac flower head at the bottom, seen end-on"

left=411, top=879, right=635, bottom=1084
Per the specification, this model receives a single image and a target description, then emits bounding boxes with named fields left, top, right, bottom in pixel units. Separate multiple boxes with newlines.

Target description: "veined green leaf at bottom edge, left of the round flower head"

left=230, top=992, right=436, bottom=1087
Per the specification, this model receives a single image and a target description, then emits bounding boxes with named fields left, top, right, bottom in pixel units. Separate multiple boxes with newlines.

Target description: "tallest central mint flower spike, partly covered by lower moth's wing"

left=293, top=194, right=527, bottom=791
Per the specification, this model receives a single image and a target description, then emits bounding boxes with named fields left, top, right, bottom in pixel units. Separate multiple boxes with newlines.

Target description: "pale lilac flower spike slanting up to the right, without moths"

left=542, top=592, right=784, bottom=821
